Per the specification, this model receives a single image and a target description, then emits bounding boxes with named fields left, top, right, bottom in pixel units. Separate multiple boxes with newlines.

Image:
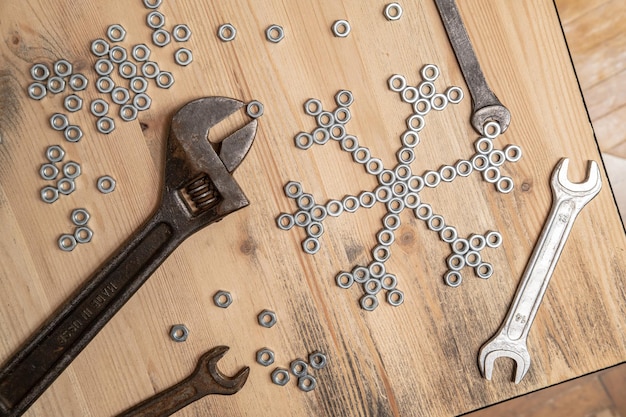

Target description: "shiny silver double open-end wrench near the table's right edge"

left=478, top=158, right=602, bottom=384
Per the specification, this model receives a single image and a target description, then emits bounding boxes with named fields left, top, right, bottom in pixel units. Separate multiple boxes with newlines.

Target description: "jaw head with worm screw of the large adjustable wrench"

left=162, top=97, right=257, bottom=232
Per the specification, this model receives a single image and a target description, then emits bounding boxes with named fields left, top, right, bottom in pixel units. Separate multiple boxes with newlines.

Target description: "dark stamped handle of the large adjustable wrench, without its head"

left=0, top=206, right=184, bottom=417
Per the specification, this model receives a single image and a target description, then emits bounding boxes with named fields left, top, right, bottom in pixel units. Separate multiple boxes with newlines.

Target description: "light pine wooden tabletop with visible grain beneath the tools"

left=0, top=0, right=626, bottom=416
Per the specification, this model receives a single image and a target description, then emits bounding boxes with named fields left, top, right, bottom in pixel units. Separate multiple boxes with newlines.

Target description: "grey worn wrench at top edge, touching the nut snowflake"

left=435, top=0, right=511, bottom=135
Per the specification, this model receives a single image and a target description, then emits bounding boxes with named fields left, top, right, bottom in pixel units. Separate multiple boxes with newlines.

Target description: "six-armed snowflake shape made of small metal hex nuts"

left=276, top=65, right=522, bottom=311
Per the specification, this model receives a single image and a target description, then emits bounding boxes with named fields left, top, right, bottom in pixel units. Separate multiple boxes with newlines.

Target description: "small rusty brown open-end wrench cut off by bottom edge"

left=118, top=346, right=250, bottom=417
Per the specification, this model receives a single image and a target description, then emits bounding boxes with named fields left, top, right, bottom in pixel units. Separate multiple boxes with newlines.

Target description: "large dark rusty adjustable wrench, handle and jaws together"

left=0, top=97, right=257, bottom=417
